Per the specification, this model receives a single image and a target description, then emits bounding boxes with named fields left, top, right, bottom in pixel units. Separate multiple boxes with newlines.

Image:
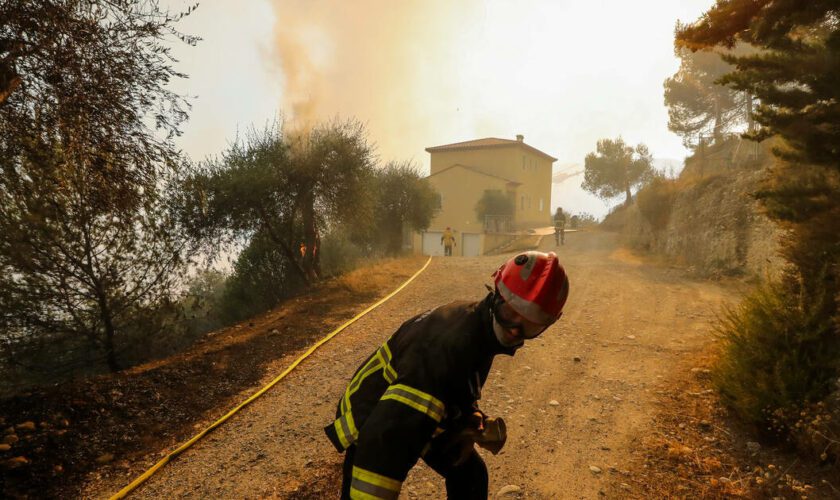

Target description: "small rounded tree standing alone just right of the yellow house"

left=581, top=137, right=653, bottom=204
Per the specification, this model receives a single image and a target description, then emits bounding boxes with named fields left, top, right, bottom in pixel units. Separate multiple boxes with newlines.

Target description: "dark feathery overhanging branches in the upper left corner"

left=0, top=0, right=198, bottom=210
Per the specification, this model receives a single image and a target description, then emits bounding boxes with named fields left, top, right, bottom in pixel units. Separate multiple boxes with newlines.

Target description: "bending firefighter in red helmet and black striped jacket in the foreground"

left=325, top=251, right=569, bottom=499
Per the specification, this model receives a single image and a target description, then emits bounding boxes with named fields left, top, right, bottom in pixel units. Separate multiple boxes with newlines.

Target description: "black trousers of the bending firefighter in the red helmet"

left=341, top=446, right=488, bottom=500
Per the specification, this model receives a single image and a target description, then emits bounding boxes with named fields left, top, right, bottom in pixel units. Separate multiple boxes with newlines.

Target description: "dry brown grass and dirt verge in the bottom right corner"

left=609, top=354, right=838, bottom=498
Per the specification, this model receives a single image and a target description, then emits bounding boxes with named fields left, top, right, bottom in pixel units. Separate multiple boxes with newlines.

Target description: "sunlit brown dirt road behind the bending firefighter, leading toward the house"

left=86, top=232, right=735, bottom=499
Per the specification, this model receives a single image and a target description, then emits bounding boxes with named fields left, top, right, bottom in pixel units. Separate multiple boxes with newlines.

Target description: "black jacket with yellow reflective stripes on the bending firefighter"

left=325, top=294, right=516, bottom=498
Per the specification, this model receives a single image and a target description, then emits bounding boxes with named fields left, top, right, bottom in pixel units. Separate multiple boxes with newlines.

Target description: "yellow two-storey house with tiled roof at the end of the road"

left=415, top=135, right=557, bottom=255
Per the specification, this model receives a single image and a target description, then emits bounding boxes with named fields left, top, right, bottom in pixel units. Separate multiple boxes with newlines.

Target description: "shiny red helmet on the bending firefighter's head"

left=493, top=251, right=569, bottom=325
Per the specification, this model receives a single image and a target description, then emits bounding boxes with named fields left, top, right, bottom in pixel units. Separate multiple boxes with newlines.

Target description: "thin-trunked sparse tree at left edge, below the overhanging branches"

left=0, top=145, right=191, bottom=371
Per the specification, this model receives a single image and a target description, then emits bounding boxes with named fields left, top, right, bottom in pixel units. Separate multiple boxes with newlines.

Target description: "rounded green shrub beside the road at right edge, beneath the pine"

left=714, top=283, right=840, bottom=437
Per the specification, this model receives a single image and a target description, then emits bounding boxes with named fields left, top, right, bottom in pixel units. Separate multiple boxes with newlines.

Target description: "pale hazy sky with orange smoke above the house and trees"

left=168, top=0, right=714, bottom=216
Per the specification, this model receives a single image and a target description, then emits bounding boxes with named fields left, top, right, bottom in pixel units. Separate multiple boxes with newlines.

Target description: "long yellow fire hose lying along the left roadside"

left=111, top=257, right=432, bottom=500
